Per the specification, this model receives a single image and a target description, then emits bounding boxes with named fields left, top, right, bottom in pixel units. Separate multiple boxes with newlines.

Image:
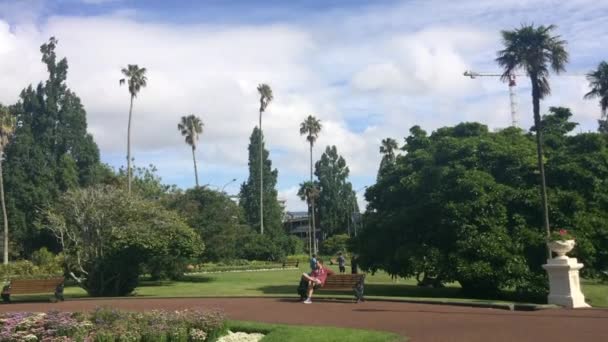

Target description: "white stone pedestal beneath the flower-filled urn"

left=543, top=256, right=590, bottom=309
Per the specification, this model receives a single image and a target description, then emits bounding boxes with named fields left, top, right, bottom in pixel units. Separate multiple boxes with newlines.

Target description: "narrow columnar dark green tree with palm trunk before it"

left=239, top=127, right=285, bottom=237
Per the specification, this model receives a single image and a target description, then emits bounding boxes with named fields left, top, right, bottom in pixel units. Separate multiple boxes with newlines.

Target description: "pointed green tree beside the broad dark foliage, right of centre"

left=315, top=146, right=355, bottom=236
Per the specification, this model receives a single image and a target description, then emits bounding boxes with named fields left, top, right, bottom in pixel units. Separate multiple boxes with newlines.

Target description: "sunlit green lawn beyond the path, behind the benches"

left=46, top=266, right=608, bottom=307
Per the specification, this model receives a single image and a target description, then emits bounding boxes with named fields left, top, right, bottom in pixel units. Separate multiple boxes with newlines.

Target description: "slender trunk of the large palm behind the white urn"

left=531, top=75, right=551, bottom=258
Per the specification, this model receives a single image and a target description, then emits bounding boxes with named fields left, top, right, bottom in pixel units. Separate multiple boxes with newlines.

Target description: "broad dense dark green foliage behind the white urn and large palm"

left=355, top=113, right=608, bottom=294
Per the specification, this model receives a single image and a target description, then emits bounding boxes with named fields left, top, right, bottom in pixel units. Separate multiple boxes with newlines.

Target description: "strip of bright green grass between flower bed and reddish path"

left=228, top=321, right=406, bottom=342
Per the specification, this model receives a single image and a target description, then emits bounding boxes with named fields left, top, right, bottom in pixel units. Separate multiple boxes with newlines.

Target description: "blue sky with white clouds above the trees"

left=0, top=0, right=608, bottom=210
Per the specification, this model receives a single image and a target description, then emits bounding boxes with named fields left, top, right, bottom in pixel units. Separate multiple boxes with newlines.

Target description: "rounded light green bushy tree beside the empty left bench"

left=46, top=186, right=203, bottom=296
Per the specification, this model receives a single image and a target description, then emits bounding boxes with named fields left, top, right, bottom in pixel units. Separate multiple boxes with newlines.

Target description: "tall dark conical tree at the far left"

left=5, top=38, right=103, bottom=254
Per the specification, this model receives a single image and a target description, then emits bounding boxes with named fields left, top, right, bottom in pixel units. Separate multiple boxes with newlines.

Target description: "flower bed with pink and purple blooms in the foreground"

left=0, top=308, right=226, bottom=342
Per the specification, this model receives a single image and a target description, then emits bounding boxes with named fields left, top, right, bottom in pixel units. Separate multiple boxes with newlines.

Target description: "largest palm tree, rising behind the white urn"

left=496, top=25, right=568, bottom=250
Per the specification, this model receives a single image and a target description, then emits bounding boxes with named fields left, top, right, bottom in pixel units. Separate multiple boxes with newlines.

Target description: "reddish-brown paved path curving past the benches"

left=0, top=298, right=608, bottom=342
